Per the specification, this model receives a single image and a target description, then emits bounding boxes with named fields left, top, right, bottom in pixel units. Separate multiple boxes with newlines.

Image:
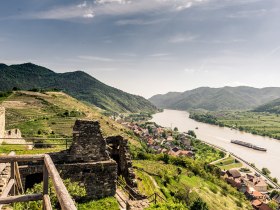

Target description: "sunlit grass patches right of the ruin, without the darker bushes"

left=133, top=160, right=252, bottom=210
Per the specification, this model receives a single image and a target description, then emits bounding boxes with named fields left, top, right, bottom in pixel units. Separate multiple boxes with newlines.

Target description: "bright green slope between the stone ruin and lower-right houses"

left=133, top=160, right=252, bottom=210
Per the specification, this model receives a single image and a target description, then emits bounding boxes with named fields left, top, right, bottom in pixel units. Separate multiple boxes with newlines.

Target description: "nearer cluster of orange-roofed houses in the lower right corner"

left=222, top=169, right=280, bottom=210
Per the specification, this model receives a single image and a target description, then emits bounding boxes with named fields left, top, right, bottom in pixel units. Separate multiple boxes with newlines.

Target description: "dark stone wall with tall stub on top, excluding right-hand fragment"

left=20, top=120, right=117, bottom=199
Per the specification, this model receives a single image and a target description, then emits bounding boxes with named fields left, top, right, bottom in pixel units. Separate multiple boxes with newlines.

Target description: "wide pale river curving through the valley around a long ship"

left=151, top=110, right=280, bottom=180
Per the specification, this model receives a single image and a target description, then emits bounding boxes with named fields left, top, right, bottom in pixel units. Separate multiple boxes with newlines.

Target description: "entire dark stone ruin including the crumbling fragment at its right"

left=20, top=120, right=139, bottom=199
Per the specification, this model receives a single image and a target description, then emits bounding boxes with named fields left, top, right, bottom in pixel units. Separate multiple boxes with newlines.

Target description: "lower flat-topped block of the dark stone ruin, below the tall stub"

left=20, top=160, right=117, bottom=200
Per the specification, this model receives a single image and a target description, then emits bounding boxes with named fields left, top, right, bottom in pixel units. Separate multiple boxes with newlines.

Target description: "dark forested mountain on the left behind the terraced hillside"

left=0, top=63, right=156, bottom=112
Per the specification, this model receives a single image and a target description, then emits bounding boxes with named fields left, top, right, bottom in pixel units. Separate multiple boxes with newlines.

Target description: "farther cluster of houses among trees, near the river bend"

left=122, top=122, right=195, bottom=158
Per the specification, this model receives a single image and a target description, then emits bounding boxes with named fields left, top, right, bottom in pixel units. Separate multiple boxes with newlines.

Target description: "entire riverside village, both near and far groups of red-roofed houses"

left=115, top=114, right=280, bottom=210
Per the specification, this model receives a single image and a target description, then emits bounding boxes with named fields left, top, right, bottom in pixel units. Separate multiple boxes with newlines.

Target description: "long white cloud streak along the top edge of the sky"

left=13, top=0, right=210, bottom=20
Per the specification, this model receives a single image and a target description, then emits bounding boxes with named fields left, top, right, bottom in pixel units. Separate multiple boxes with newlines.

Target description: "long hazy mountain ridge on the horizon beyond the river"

left=149, top=86, right=280, bottom=111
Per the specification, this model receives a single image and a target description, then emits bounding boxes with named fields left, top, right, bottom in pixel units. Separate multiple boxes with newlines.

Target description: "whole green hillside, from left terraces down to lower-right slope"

left=0, top=91, right=251, bottom=210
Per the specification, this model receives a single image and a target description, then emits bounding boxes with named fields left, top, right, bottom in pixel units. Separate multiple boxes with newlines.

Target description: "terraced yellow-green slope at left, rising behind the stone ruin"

left=0, top=91, right=140, bottom=153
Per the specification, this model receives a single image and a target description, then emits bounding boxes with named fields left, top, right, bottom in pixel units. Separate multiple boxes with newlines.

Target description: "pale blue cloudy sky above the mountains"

left=0, top=0, right=280, bottom=98
